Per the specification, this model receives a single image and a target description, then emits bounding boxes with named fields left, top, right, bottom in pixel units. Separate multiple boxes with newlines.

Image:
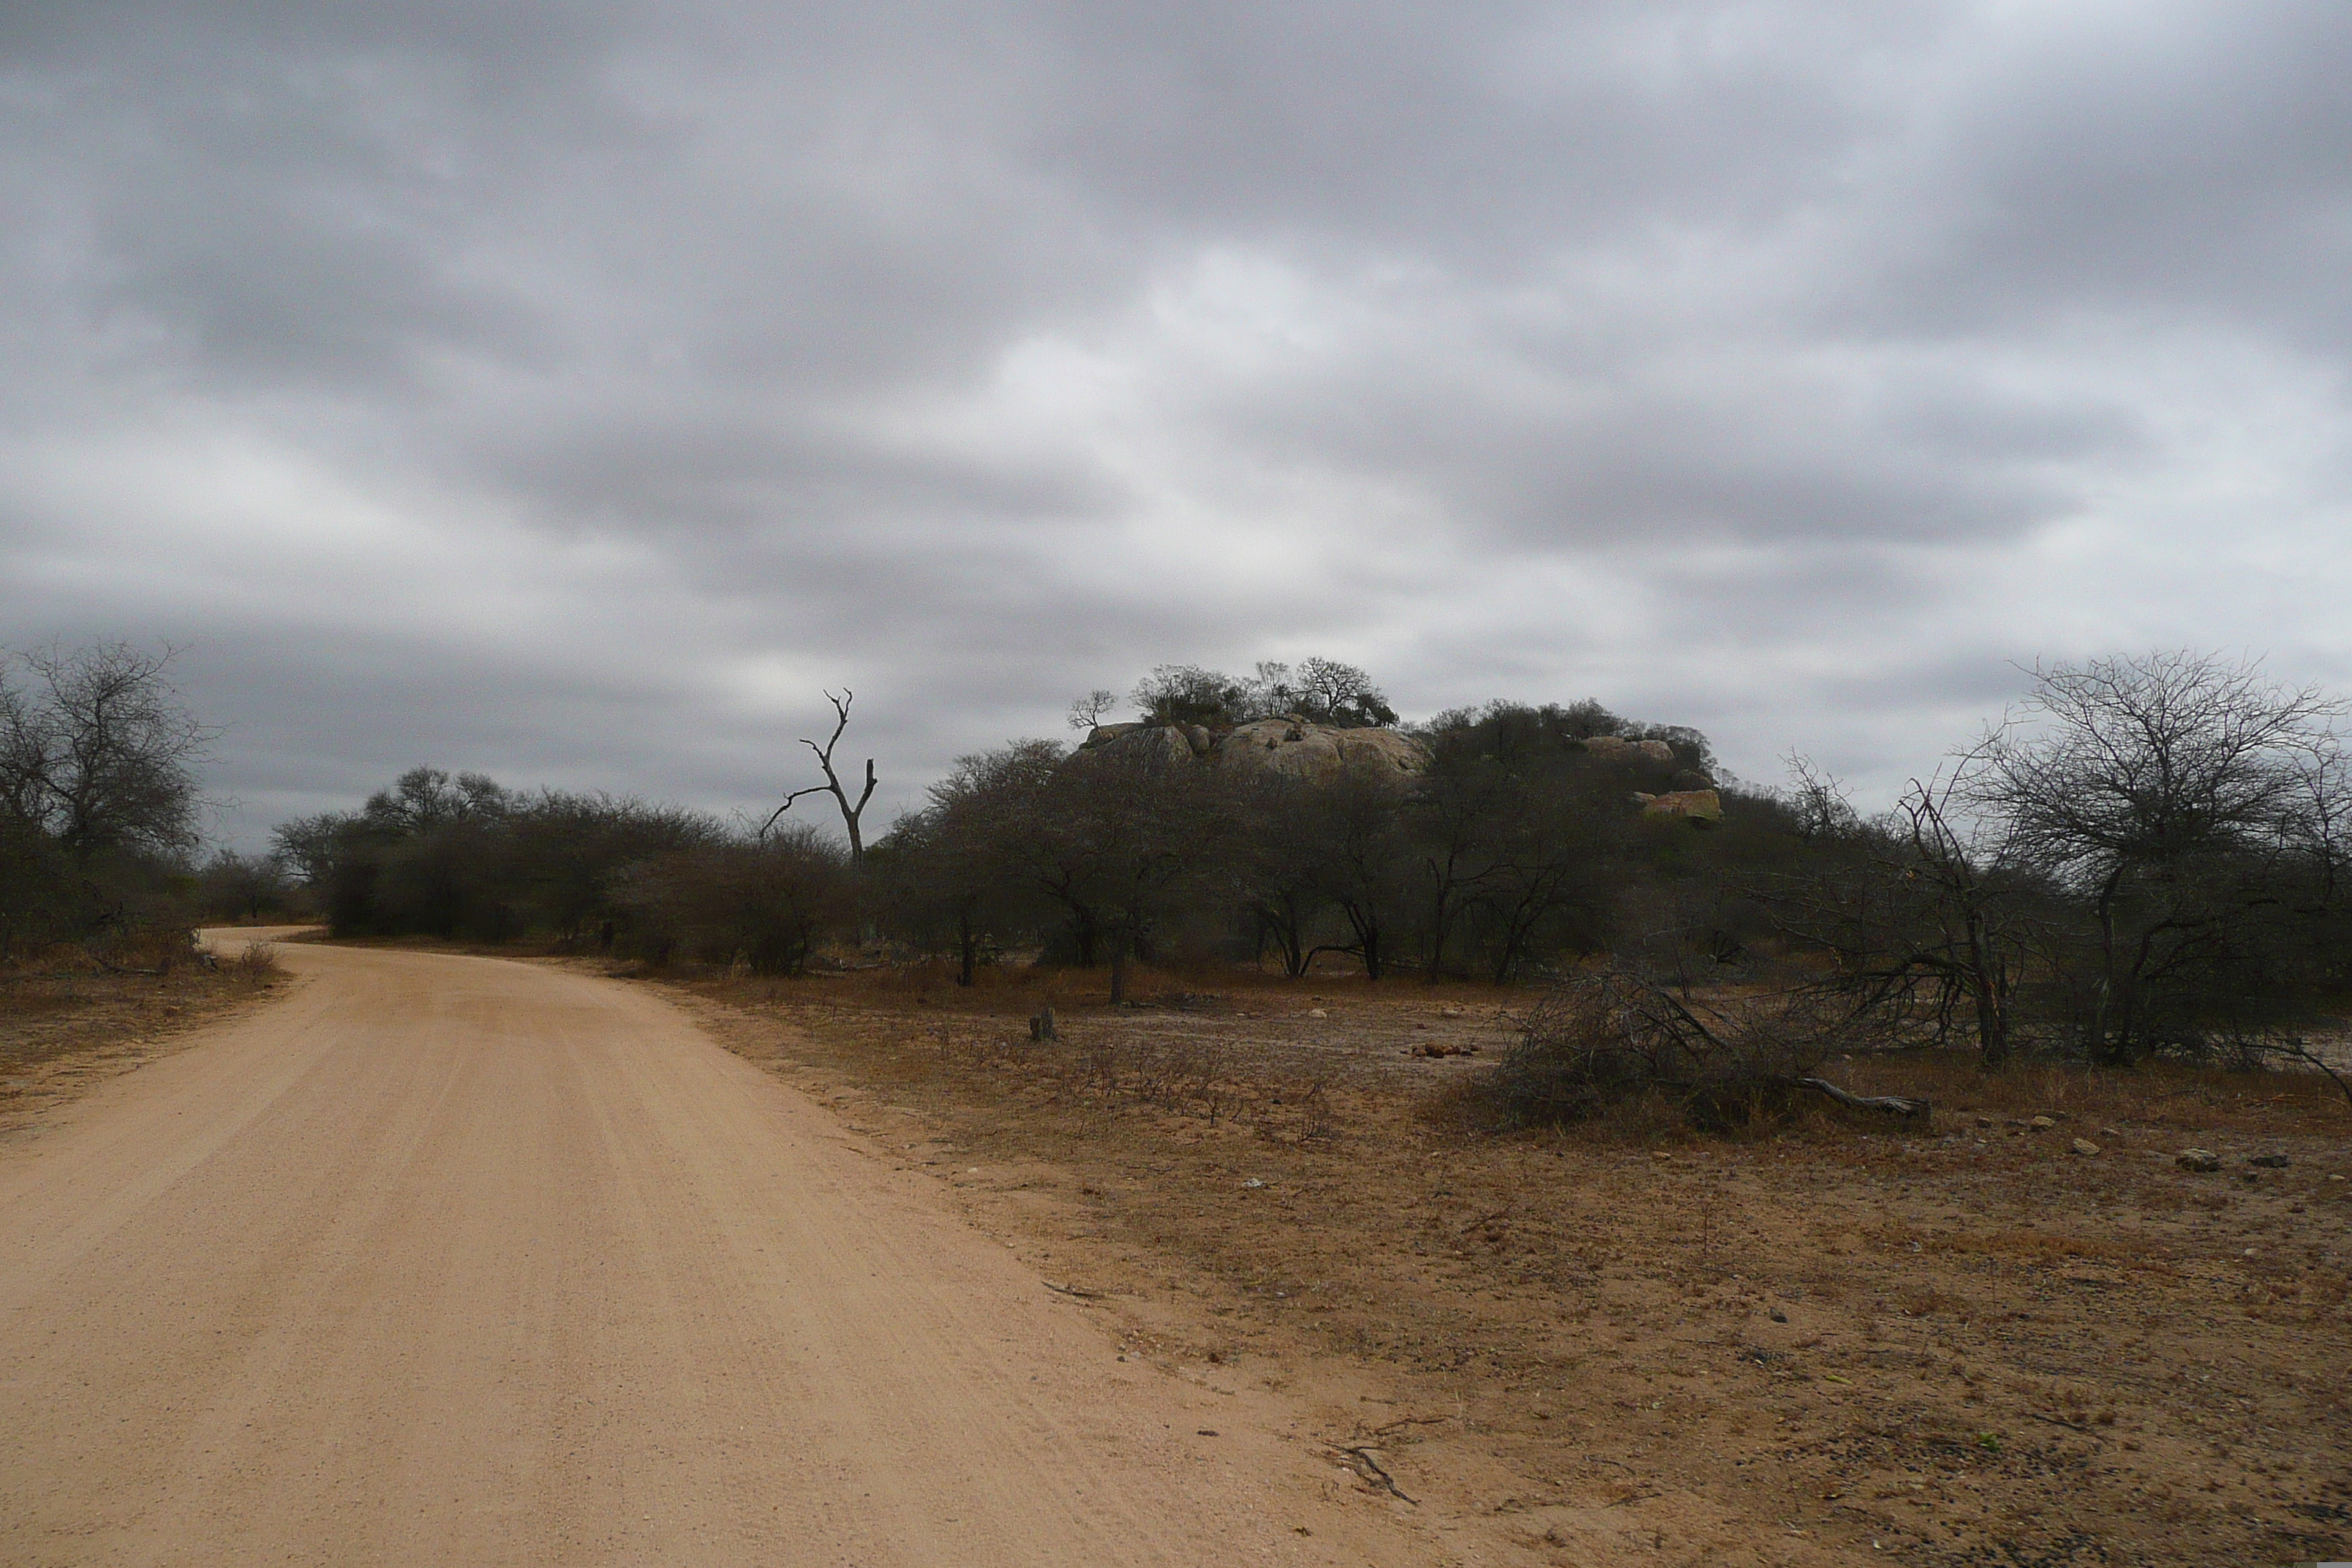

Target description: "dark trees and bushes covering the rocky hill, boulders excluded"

left=872, top=691, right=1804, bottom=992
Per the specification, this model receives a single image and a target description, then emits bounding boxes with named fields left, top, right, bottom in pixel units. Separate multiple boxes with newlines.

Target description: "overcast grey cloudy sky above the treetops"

left=0, top=0, right=2352, bottom=842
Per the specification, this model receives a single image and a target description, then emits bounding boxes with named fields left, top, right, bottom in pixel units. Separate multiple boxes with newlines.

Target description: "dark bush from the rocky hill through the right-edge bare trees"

left=875, top=654, right=2352, bottom=1093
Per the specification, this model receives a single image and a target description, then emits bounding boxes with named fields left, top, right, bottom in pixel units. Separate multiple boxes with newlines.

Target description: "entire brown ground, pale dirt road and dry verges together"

left=0, top=930, right=2352, bottom=1568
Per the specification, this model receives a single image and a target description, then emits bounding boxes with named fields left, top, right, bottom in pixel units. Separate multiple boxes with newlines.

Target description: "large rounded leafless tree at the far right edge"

left=1959, top=654, right=2352, bottom=1065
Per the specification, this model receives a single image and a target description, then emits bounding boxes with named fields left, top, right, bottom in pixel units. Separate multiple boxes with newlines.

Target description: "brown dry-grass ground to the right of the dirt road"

left=644, top=971, right=2352, bottom=1568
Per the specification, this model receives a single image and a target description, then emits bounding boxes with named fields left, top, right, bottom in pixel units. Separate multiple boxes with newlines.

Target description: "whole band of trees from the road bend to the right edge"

left=277, top=656, right=2352, bottom=1081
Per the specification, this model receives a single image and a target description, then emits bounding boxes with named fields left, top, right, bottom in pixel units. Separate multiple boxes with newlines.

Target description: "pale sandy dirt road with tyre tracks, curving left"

left=0, top=947, right=1433, bottom=1568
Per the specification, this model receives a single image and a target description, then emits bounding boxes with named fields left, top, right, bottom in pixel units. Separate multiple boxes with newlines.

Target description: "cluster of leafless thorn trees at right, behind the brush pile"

left=1757, top=654, right=2352, bottom=1067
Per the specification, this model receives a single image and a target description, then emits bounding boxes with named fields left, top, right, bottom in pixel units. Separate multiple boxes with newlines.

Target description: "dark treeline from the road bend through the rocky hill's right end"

left=277, top=703, right=1801, bottom=985
